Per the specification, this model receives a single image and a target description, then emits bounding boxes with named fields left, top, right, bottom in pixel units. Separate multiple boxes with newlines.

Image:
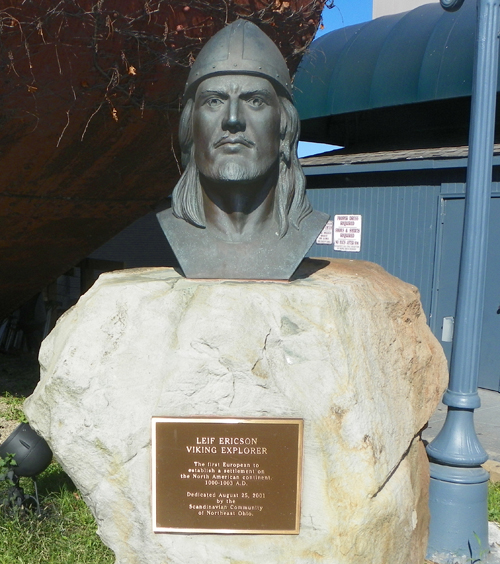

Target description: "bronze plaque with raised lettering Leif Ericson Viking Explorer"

left=152, top=417, right=303, bottom=535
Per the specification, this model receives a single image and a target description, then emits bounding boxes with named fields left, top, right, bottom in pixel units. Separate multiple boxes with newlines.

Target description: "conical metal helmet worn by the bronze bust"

left=184, top=20, right=292, bottom=102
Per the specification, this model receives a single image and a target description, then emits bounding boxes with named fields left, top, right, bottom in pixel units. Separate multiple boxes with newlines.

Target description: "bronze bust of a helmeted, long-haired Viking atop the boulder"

left=158, top=20, right=328, bottom=280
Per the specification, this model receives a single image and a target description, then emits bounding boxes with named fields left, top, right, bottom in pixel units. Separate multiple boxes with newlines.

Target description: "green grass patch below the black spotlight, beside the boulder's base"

left=0, top=463, right=115, bottom=564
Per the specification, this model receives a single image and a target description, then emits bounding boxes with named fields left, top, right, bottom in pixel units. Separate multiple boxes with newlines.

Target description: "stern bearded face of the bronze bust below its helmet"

left=193, top=75, right=280, bottom=182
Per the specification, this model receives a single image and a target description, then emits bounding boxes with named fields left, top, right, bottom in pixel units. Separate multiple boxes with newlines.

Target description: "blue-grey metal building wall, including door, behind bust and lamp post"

left=306, top=172, right=500, bottom=390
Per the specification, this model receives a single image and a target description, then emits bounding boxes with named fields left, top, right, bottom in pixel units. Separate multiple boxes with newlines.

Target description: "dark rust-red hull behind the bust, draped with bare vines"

left=0, top=0, right=324, bottom=319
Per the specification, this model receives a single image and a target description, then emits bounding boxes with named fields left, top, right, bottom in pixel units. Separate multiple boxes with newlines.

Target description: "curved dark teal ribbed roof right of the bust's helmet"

left=294, top=0, right=476, bottom=120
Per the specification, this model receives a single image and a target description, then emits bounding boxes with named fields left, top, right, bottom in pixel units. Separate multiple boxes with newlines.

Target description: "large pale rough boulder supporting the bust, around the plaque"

left=25, top=260, right=447, bottom=564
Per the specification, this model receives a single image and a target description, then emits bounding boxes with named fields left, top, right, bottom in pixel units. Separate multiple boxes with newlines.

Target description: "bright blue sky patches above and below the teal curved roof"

left=299, top=0, right=372, bottom=157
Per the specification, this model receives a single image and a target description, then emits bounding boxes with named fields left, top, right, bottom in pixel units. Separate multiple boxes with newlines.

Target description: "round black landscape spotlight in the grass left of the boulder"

left=0, top=423, right=52, bottom=514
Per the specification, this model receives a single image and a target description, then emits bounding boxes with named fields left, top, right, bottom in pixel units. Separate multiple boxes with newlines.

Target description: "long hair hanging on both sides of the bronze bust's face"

left=172, top=92, right=312, bottom=238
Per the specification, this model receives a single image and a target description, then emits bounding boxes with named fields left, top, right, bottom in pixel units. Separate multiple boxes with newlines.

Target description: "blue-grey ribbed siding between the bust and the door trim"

left=308, top=186, right=440, bottom=315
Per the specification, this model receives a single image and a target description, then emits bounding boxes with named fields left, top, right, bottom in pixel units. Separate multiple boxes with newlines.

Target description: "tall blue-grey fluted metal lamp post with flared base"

left=427, top=0, right=500, bottom=564
